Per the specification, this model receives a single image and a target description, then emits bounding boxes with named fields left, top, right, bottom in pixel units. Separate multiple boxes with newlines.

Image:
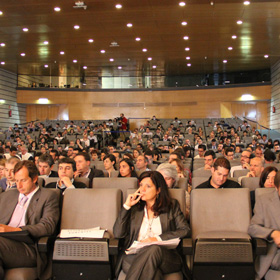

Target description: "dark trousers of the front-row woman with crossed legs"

left=122, top=245, right=182, bottom=280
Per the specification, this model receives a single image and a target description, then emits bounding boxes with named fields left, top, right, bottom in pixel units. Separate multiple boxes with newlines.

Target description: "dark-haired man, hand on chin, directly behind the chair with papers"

left=45, top=158, right=86, bottom=194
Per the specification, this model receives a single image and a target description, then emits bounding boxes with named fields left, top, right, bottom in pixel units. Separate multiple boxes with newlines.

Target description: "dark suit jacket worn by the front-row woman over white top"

left=113, top=200, right=190, bottom=275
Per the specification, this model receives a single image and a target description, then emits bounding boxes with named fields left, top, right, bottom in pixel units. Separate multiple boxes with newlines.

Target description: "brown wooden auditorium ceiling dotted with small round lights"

left=0, top=0, right=280, bottom=76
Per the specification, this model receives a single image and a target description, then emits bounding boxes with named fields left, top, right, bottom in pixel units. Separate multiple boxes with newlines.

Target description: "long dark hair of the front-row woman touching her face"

left=139, top=171, right=172, bottom=216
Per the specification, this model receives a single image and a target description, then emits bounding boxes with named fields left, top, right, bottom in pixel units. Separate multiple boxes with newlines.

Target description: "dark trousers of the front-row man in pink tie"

left=0, top=237, right=37, bottom=279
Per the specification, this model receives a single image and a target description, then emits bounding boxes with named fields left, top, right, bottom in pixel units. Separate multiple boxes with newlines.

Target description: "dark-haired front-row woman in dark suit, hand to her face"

left=114, top=171, right=190, bottom=280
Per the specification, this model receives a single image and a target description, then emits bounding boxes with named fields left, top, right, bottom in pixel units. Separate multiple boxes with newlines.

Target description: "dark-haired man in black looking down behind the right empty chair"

left=196, top=157, right=241, bottom=189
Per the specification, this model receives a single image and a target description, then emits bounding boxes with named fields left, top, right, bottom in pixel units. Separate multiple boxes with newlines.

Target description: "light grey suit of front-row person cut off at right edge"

left=248, top=190, right=280, bottom=279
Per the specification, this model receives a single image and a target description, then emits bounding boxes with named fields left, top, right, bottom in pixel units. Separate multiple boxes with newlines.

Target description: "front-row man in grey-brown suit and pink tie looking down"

left=0, top=160, right=60, bottom=279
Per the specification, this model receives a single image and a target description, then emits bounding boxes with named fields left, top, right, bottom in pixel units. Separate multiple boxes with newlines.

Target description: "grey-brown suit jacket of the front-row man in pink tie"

left=0, top=188, right=60, bottom=275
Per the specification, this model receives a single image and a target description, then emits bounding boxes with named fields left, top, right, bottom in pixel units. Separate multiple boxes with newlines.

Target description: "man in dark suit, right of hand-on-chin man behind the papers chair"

left=74, top=152, right=104, bottom=188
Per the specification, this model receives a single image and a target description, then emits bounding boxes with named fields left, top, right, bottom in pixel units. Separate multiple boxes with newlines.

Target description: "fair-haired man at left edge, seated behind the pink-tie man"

left=0, top=157, right=20, bottom=191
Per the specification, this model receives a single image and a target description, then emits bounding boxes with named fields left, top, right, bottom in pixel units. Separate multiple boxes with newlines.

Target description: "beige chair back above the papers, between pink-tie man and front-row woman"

left=61, top=188, right=121, bottom=237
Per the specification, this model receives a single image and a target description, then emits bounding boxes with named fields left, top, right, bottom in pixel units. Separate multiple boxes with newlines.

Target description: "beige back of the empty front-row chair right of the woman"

left=190, top=188, right=251, bottom=240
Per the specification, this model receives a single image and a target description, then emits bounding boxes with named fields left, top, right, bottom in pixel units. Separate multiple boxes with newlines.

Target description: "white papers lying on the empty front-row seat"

left=60, top=227, right=105, bottom=238
